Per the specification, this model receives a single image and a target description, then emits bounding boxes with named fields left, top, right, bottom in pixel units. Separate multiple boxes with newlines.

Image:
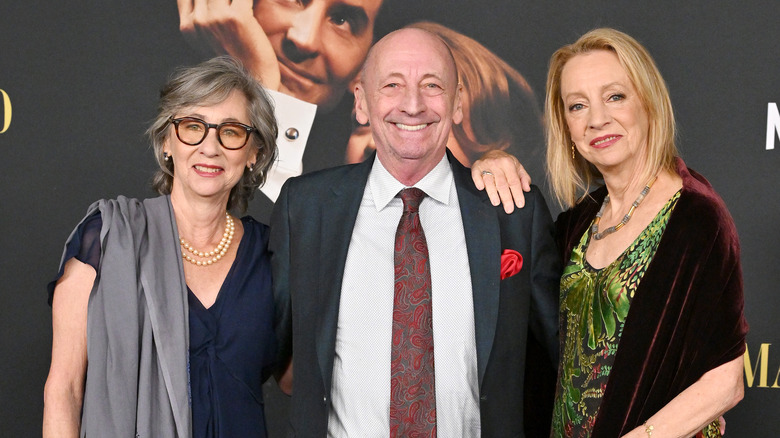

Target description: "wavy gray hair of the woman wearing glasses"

left=146, top=56, right=277, bottom=212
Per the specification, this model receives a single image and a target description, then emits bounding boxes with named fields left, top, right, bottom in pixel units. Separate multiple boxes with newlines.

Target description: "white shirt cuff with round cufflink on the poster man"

left=260, top=90, right=317, bottom=202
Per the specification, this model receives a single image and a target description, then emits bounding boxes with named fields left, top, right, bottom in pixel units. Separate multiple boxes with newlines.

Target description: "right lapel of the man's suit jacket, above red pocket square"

left=447, top=151, right=501, bottom=387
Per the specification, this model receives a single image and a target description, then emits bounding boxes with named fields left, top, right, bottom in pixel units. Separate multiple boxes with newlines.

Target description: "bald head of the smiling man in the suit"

left=355, top=28, right=463, bottom=186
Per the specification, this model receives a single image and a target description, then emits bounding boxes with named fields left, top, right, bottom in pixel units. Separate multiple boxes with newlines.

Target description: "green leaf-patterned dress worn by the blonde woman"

left=552, top=192, right=708, bottom=438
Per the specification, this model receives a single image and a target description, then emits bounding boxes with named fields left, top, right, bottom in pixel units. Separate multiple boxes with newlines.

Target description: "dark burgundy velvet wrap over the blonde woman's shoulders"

left=556, top=159, right=748, bottom=438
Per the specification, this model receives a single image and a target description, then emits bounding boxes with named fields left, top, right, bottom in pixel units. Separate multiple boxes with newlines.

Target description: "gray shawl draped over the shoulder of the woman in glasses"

left=57, top=196, right=192, bottom=438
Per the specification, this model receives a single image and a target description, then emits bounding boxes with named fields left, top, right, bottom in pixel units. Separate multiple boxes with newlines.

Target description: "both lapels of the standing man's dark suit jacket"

left=317, top=151, right=501, bottom=391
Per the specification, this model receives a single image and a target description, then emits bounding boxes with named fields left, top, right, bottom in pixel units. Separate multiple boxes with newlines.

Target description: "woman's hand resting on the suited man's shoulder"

left=471, top=150, right=531, bottom=214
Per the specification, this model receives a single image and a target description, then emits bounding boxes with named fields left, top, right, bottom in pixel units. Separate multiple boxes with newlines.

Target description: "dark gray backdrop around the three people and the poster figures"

left=0, top=0, right=780, bottom=437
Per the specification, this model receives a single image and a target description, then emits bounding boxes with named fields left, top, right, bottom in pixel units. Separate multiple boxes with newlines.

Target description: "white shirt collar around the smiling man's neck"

left=368, top=154, right=453, bottom=211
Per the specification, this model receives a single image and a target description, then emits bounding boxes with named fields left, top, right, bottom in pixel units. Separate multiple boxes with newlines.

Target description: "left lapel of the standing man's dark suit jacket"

left=316, top=158, right=374, bottom=391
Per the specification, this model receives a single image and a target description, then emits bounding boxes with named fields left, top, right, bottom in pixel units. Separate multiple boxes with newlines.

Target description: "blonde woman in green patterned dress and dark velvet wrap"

left=475, top=29, right=748, bottom=438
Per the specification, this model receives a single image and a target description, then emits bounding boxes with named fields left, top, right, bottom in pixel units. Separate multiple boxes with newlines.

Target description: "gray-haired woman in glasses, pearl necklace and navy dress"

left=43, top=57, right=287, bottom=437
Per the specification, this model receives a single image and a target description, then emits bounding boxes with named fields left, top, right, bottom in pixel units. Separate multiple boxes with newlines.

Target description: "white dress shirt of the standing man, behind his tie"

left=328, top=156, right=480, bottom=438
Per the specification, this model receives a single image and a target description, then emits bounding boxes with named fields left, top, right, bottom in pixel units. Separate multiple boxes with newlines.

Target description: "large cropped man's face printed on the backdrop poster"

left=254, top=0, right=382, bottom=110
